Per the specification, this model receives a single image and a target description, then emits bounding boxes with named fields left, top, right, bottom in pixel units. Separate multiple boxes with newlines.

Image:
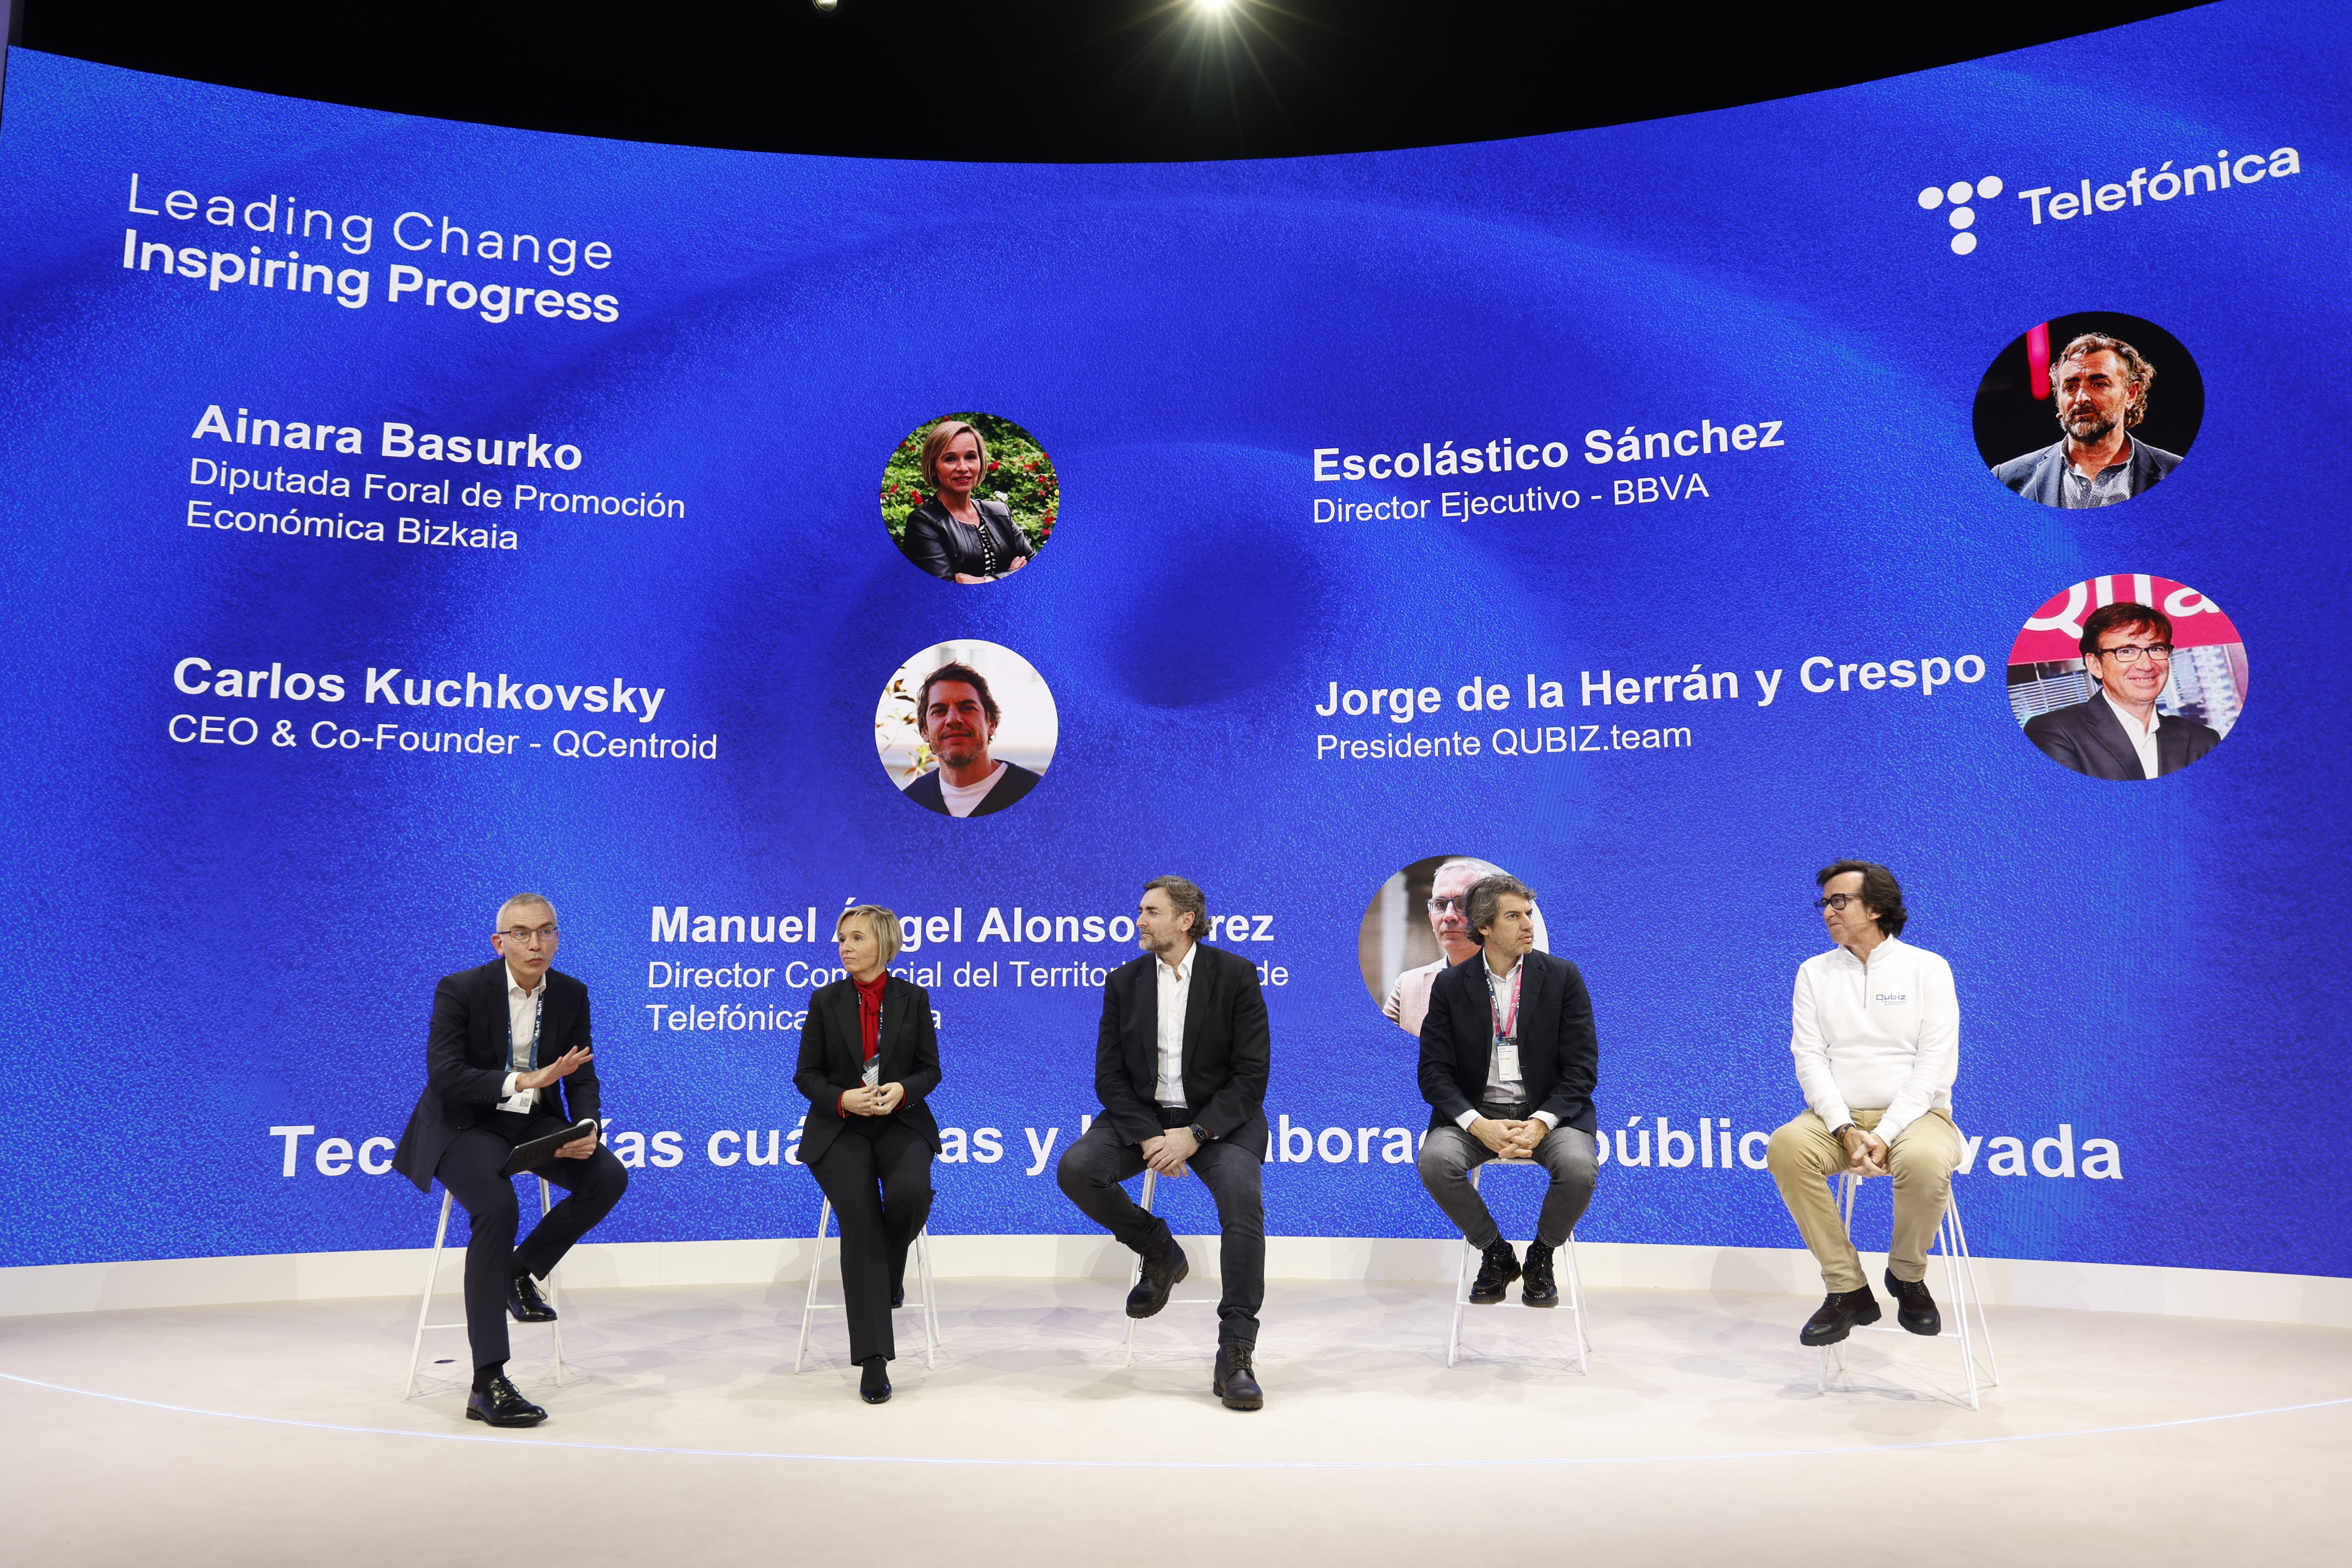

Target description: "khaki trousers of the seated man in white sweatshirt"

left=1764, top=1107, right=1962, bottom=1290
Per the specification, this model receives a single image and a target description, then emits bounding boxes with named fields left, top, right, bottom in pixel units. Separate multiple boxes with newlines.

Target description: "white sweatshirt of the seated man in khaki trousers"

left=1790, top=938, right=1959, bottom=1143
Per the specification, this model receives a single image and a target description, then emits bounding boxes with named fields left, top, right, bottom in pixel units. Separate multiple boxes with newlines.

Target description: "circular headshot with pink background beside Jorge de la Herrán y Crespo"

left=2009, top=573, right=2246, bottom=780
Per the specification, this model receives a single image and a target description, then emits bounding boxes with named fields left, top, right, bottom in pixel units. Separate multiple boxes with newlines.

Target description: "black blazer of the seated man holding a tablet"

left=393, top=959, right=600, bottom=1192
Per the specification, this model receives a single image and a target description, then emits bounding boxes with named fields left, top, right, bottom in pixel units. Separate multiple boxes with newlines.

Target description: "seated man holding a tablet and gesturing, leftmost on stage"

left=393, top=893, right=628, bottom=1427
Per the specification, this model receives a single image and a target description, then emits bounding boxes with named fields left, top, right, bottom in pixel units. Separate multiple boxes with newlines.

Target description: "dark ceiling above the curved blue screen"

left=19, top=0, right=2187, bottom=162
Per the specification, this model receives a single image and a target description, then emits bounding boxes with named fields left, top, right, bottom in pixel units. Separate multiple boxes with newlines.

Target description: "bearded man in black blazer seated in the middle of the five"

left=1056, top=877, right=1270, bottom=1410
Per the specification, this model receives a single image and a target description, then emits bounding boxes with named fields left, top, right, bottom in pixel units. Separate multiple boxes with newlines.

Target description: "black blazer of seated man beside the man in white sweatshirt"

left=1421, top=952, right=1602, bottom=1133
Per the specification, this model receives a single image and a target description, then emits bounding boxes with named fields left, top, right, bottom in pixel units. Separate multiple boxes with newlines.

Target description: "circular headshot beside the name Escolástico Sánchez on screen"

left=1976, top=310, right=2204, bottom=508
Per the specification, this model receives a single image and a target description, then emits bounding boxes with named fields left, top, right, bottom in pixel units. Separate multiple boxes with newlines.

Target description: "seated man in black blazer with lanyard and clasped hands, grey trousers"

left=1421, top=877, right=1599, bottom=1307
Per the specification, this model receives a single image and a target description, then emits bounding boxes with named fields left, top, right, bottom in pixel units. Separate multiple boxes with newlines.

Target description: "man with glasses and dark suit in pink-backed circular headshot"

left=2025, top=604, right=2220, bottom=780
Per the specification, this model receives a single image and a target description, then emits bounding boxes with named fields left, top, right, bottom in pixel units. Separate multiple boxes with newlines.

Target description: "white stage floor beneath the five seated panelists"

left=0, top=1279, right=2352, bottom=1568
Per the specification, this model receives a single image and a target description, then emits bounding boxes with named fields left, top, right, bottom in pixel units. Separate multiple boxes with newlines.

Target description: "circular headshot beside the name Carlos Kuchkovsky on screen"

left=875, top=639, right=1061, bottom=816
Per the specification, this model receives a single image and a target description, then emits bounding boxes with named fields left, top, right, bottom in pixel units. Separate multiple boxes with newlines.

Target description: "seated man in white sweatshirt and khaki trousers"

left=1766, top=860, right=1962, bottom=1345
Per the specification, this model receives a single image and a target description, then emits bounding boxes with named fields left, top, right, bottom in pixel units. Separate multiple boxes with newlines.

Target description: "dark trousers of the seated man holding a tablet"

left=435, top=1110, right=628, bottom=1368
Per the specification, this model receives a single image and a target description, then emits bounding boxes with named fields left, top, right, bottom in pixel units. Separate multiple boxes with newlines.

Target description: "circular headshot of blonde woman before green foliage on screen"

left=882, top=414, right=1061, bottom=583
